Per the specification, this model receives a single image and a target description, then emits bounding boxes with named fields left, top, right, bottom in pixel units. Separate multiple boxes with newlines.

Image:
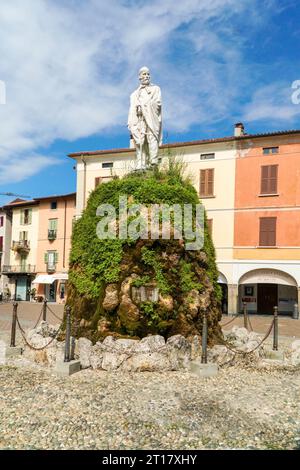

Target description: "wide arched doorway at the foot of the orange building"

left=239, top=269, right=298, bottom=315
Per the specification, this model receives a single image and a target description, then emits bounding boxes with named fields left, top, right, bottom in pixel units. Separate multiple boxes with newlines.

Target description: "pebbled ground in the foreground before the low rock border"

left=0, top=359, right=300, bottom=450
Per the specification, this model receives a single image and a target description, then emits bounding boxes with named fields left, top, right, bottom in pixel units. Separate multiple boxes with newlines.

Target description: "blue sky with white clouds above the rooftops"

left=0, top=0, right=300, bottom=205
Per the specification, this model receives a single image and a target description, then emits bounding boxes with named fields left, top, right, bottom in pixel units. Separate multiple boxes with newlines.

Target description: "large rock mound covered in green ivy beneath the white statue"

left=67, top=160, right=221, bottom=343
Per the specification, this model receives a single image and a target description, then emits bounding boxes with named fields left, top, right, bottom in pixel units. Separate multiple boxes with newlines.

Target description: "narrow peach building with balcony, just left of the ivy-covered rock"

left=32, top=193, right=76, bottom=303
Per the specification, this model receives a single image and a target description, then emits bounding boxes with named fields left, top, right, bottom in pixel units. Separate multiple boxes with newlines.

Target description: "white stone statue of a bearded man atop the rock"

left=128, top=67, right=162, bottom=170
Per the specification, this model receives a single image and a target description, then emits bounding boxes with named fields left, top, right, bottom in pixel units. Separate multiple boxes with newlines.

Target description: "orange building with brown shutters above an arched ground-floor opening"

left=232, top=130, right=300, bottom=314
